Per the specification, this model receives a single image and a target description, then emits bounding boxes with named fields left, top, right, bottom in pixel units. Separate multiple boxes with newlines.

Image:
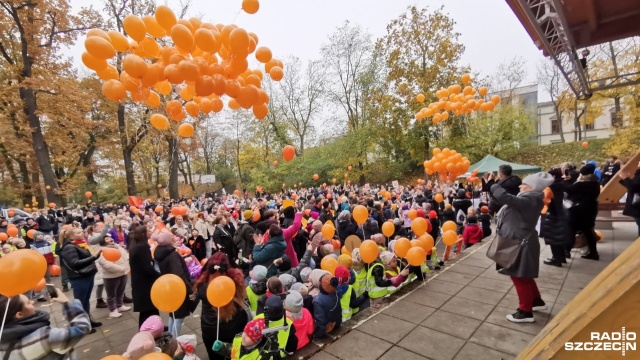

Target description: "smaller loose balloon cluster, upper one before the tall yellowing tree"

left=416, top=74, right=500, bottom=125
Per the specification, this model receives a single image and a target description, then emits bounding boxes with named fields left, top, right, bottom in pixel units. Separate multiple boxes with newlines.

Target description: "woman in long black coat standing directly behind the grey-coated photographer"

left=540, top=168, right=573, bottom=267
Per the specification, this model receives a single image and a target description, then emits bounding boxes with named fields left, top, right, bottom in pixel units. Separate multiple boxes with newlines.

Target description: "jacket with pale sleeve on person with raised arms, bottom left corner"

left=0, top=300, right=91, bottom=360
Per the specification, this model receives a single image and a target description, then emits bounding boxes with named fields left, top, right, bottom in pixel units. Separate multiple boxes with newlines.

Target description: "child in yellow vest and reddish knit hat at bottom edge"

left=212, top=319, right=267, bottom=359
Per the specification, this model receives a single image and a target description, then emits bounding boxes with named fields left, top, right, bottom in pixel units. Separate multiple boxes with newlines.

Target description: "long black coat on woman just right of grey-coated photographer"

left=540, top=179, right=573, bottom=246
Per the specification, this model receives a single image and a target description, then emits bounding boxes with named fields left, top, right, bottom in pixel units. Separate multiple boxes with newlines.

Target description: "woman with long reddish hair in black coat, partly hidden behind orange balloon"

left=193, top=251, right=249, bottom=360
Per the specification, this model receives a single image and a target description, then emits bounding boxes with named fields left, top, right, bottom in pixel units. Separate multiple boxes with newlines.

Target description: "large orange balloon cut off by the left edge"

left=0, top=249, right=47, bottom=298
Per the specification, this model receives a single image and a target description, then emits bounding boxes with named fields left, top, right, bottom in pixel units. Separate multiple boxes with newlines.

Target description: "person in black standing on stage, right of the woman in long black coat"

left=566, top=164, right=600, bottom=260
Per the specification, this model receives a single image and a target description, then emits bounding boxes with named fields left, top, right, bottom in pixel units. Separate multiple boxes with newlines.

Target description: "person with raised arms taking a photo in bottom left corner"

left=0, top=289, right=93, bottom=359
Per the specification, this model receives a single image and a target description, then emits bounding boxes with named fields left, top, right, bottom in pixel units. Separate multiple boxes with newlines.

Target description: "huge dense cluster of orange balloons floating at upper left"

left=82, top=4, right=284, bottom=137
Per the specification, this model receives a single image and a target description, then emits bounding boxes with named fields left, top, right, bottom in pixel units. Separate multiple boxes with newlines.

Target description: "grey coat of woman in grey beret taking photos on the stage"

left=491, top=184, right=544, bottom=278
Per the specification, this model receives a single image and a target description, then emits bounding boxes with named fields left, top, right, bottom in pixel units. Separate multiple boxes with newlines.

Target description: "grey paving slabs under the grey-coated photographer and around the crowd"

left=37, top=223, right=637, bottom=360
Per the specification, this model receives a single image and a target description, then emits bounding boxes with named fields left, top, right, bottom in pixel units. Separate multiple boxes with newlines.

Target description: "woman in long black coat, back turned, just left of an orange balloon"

left=129, top=225, right=160, bottom=327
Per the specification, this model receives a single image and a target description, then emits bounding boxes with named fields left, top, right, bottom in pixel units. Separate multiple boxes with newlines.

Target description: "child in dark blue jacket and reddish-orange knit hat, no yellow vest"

left=313, top=274, right=342, bottom=338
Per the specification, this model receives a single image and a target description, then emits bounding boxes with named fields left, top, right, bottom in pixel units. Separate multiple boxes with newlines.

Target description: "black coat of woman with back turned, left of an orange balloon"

left=129, top=244, right=160, bottom=312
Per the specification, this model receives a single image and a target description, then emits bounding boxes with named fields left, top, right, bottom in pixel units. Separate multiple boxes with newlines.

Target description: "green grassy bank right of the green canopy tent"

left=504, top=139, right=608, bottom=170
